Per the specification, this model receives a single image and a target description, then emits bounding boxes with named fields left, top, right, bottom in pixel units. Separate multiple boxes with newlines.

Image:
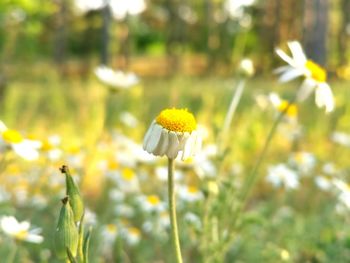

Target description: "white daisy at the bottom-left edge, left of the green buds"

left=0, top=216, right=44, bottom=244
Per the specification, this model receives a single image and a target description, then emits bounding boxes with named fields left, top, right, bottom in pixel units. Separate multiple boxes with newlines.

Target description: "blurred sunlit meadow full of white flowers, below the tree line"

left=0, top=59, right=350, bottom=263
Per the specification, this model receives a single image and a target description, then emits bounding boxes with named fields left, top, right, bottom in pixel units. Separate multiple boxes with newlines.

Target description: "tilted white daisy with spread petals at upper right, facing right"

left=275, top=41, right=334, bottom=113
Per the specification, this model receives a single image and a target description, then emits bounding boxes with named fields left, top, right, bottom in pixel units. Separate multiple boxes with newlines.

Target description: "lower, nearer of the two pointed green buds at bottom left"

left=55, top=197, right=79, bottom=259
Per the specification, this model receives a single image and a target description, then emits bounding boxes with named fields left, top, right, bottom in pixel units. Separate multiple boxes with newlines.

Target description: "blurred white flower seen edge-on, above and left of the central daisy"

left=95, top=66, right=139, bottom=90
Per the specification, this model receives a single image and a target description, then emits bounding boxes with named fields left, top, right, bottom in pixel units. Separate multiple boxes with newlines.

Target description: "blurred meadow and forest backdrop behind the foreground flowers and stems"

left=0, top=0, right=350, bottom=263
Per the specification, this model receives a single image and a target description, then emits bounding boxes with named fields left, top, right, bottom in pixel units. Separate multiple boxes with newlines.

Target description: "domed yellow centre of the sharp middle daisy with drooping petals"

left=156, top=108, right=197, bottom=132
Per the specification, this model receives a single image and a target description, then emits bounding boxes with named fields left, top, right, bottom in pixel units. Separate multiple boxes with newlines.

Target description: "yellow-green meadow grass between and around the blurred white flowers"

left=0, top=65, right=350, bottom=263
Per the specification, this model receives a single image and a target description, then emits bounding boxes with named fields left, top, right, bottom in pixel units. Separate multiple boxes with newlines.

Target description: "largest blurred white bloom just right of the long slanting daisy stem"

left=266, top=163, right=299, bottom=189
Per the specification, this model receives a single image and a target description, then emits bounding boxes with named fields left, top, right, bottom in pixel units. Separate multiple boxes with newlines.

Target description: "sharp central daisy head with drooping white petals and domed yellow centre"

left=143, top=108, right=201, bottom=160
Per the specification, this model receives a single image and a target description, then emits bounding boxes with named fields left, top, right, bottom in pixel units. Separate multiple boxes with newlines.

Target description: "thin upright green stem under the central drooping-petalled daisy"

left=168, top=158, right=182, bottom=263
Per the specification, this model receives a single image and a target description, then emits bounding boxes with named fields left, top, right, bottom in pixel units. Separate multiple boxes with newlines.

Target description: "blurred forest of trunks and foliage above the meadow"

left=0, top=0, right=350, bottom=77
